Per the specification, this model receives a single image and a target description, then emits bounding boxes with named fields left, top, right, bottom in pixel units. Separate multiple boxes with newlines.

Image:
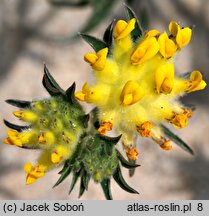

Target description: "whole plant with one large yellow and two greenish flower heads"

left=4, top=7, right=206, bottom=199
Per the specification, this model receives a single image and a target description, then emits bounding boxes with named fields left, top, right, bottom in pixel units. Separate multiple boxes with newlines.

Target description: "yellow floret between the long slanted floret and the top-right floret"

left=158, top=32, right=177, bottom=58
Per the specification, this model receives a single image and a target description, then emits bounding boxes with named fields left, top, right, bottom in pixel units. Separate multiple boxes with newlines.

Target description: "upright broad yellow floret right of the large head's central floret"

left=155, top=63, right=174, bottom=94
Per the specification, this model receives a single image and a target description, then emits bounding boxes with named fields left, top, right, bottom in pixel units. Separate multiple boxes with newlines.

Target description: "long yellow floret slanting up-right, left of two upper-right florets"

left=131, top=37, right=159, bottom=65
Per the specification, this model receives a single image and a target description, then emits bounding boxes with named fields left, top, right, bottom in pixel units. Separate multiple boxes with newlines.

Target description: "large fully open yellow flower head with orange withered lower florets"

left=76, top=7, right=206, bottom=160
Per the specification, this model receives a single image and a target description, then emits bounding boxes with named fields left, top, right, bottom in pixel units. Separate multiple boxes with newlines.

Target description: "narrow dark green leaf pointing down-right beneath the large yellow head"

left=161, top=125, right=194, bottom=155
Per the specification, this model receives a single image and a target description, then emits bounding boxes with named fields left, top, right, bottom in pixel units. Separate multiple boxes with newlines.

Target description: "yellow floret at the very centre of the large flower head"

left=120, top=80, right=144, bottom=105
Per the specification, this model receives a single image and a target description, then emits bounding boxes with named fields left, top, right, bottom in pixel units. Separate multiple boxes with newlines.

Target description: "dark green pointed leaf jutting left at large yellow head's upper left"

left=80, top=34, right=108, bottom=52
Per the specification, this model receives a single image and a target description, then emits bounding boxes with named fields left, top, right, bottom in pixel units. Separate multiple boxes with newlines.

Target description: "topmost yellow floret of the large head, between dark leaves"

left=114, top=18, right=136, bottom=40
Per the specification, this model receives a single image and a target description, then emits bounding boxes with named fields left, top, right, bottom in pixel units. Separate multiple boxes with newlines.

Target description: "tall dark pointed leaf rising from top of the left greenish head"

left=42, top=65, right=65, bottom=96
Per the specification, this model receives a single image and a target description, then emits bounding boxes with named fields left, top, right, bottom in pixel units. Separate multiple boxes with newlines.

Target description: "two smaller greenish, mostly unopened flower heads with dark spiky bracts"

left=4, top=66, right=138, bottom=199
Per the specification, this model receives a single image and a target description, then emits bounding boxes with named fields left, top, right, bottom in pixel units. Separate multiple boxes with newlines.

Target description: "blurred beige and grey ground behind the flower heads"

left=0, top=0, right=209, bottom=200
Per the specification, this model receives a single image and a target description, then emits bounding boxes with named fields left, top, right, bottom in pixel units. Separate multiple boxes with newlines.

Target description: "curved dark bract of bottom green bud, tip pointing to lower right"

left=113, top=166, right=139, bottom=194
